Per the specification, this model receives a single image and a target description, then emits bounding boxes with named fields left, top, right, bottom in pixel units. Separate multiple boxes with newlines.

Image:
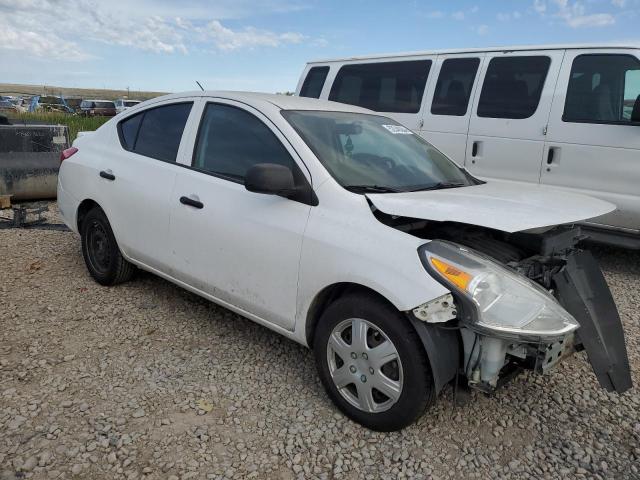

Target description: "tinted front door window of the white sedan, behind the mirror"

left=193, top=104, right=294, bottom=182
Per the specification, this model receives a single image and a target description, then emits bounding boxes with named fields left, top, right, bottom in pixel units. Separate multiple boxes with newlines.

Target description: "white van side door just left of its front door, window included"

left=465, top=50, right=563, bottom=183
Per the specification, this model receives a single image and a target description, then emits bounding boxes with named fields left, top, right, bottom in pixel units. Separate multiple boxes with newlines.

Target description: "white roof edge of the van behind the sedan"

left=307, top=42, right=640, bottom=65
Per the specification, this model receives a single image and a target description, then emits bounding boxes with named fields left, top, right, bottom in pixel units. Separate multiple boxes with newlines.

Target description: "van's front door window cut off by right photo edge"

left=562, top=54, right=640, bottom=123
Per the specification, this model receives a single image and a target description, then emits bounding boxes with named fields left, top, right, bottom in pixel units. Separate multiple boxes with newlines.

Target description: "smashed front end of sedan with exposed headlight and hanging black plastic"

left=412, top=226, right=632, bottom=393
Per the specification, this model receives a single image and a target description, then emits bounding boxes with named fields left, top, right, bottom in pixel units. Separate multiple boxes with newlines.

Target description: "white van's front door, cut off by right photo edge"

left=541, top=49, right=640, bottom=232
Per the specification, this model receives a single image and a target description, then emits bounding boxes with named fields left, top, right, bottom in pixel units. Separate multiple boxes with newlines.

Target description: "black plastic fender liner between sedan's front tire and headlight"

left=407, top=313, right=460, bottom=395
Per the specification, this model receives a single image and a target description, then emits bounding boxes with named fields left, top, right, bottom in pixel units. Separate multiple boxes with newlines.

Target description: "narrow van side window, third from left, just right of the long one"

left=431, top=58, right=480, bottom=116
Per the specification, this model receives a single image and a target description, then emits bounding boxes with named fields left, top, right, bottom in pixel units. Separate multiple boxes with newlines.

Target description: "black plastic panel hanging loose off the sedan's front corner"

left=553, top=251, right=632, bottom=393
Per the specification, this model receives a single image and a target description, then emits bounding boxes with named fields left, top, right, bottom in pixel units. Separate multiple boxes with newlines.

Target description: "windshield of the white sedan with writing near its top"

left=282, top=110, right=474, bottom=193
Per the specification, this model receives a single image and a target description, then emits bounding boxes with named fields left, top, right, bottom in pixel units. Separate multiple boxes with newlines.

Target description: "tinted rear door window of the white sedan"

left=118, top=103, right=193, bottom=162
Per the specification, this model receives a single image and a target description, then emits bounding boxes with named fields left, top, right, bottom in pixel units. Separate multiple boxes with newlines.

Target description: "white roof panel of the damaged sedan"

left=143, top=90, right=373, bottom=113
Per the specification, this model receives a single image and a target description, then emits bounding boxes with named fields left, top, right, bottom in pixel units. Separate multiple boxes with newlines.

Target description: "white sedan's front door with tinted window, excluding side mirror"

left=170, top=101, right=311, bottom=330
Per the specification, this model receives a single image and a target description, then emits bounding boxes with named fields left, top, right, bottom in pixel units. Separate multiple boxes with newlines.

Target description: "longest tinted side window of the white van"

left=329, top=60, right=431, bottom=113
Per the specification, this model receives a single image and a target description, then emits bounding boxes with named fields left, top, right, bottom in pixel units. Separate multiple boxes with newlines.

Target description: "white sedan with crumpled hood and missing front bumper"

left=58, top=92, right=631, bottom=430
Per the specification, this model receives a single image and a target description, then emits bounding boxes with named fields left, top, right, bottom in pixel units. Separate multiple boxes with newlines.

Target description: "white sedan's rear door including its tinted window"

left=100, top=99, right=193, bottom=273
